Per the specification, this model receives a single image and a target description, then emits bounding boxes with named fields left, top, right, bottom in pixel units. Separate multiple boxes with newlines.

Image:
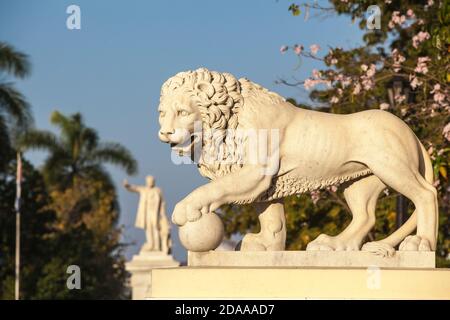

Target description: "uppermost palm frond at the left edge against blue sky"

left=0, top=42, right=31, bottom=78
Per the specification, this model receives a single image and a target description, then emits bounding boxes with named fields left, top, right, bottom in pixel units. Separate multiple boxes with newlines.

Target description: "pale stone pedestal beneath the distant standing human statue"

left=126, top=251, right=180, bottom=300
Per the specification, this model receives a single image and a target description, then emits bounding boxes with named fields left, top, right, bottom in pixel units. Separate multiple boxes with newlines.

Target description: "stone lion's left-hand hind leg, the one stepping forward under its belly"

left=306, top=175, right=386, bottom=251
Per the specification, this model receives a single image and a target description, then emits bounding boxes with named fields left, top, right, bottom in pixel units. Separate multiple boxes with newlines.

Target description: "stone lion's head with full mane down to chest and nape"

left=159, top=68, right=284, bottom=179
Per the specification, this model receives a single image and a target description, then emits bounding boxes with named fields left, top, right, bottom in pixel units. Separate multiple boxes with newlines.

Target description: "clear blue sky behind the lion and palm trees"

left=0, top=0, right=361, bottom=260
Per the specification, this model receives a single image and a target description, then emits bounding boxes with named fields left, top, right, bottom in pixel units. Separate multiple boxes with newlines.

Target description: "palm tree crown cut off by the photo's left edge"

left=0, top=42, right=33, bottom=165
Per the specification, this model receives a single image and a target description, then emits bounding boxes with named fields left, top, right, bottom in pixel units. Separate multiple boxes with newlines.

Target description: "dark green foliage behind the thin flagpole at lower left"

left=0, top=154, right=55, bottom=299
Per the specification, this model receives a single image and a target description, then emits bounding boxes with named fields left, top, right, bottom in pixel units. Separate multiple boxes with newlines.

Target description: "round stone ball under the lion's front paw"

left=179, top=212, right=224, bottom=252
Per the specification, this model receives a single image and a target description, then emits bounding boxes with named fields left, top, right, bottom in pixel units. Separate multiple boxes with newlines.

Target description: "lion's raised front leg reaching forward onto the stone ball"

left=172, top=165, right=273, bottom=225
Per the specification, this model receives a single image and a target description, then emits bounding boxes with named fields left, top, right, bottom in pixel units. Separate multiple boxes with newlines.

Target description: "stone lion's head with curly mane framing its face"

left=159, top=68, right=243, bottom=178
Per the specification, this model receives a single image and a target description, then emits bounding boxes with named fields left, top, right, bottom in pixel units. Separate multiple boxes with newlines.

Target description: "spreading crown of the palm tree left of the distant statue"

left=19, top=111, right=137, bottom=189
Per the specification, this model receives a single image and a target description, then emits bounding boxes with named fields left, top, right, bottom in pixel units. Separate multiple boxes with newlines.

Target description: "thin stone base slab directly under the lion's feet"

left=188, top=251, right=435, bottom=268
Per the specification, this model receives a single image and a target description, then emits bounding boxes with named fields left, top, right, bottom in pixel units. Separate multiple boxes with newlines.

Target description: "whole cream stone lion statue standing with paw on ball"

left=159, top=68, right=438, bottom=255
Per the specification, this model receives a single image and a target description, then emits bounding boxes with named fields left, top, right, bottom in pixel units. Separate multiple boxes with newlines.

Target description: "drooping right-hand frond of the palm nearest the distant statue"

left=89, top=142, right=137, bottom=174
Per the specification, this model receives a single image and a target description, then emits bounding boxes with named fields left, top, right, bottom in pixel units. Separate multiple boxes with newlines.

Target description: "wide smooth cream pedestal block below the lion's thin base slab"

left=151, top=267, right=450, bottom=299
